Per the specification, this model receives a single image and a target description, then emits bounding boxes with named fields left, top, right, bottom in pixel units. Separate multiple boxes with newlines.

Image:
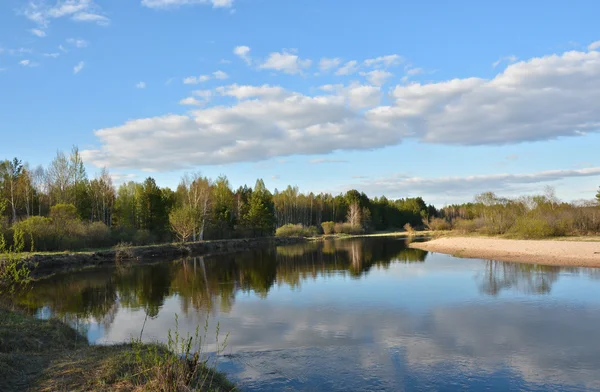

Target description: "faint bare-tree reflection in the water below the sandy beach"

left=477, top=260, right=579, bottom=296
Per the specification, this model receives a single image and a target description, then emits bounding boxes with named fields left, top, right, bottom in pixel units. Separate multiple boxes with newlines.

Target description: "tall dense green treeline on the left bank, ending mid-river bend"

left=0, top=147, right=437, bottom=251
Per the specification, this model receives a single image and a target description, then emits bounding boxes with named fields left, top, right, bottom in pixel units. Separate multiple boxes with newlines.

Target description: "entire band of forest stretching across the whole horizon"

left=0, top=146, right=600, bottom=251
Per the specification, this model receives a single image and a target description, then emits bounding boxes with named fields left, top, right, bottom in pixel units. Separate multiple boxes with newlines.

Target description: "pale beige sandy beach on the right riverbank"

left=410, top=237, right=600, bottom=267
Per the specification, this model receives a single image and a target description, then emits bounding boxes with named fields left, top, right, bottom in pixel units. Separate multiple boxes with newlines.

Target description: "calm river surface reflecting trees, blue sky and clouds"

left=21, top=238, right=600, bottom=391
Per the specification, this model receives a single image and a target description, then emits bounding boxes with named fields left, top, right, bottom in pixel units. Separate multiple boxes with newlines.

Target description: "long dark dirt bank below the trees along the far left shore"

left=26, top=237, right=305, bottom=279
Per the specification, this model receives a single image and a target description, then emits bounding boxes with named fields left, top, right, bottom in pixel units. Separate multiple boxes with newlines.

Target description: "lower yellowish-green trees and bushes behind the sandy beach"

left=428, top=188, right=600, bottom=238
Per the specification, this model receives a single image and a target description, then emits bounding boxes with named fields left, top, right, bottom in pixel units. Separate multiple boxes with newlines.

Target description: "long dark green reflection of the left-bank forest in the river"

left=19, top=239, right=427, bottom=328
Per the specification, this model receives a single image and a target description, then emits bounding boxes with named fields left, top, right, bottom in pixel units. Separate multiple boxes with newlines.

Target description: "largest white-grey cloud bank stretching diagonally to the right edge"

left=86, top=51, right=600, bottom=170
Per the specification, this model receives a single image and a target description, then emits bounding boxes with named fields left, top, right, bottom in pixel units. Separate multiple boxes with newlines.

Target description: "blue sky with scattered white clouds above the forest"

left=0, top=0, right=600, bottom=207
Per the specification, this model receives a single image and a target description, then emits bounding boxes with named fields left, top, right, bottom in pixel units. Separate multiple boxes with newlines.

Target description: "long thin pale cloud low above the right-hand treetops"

left=350, top=167, right=600, bottom=201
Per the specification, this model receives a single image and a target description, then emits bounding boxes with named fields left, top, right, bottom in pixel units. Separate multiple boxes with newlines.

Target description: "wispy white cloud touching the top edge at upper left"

left=22, top=0, right=110, bottom=27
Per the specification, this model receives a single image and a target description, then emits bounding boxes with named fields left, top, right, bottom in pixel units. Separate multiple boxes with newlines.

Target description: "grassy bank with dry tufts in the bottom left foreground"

left=0, top=308, right=234, bottom=391
